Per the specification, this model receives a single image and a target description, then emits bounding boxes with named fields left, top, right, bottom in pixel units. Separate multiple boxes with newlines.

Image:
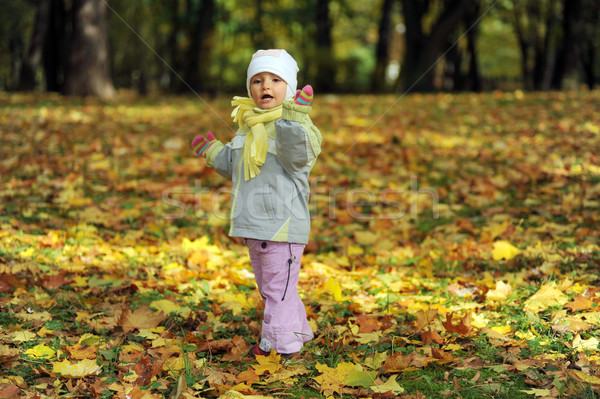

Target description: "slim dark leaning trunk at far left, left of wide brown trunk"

left=19, top=0, right=50, bottom=91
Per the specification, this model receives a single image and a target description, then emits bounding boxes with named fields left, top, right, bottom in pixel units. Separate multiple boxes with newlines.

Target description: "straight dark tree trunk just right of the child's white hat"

left=313, top=0, right=335, bottom=93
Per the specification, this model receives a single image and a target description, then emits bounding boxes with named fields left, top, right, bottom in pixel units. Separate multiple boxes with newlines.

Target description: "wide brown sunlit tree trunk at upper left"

left=63, top=0, right=116, bottom=100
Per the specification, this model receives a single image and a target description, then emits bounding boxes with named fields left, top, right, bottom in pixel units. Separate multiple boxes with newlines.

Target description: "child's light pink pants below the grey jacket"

left=246, top=239, right=314, bottom=353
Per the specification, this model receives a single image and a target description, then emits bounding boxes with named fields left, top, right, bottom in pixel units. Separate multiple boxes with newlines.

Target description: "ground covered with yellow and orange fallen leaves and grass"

left=0, top=91, right=600, bottom=398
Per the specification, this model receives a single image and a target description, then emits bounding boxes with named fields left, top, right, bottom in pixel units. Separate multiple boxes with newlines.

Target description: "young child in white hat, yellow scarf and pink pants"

left=192, top=50, right=322, bottom=358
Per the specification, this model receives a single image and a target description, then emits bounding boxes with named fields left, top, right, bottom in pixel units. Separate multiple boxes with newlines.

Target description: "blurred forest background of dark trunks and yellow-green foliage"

left=0, top=0, right=600, bottom=99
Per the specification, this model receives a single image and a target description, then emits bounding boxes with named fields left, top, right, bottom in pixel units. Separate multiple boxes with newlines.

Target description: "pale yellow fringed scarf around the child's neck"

left=231, top=96, right=282, bottom=180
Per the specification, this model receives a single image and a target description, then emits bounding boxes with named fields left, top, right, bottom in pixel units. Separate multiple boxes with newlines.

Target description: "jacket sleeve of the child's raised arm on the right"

left=275, top=102, right=322, bottom=176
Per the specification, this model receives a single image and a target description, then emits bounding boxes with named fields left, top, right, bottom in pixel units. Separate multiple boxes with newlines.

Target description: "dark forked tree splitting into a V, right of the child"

left=397, top=0, right=476, bottom=91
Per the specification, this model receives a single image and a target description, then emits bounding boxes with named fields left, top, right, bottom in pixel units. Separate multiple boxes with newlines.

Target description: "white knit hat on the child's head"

left=246, top=49, right=298, bottom=100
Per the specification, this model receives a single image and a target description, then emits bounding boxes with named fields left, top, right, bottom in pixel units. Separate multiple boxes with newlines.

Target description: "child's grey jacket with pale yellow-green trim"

left=206, top=102, right=322, bottom=244
